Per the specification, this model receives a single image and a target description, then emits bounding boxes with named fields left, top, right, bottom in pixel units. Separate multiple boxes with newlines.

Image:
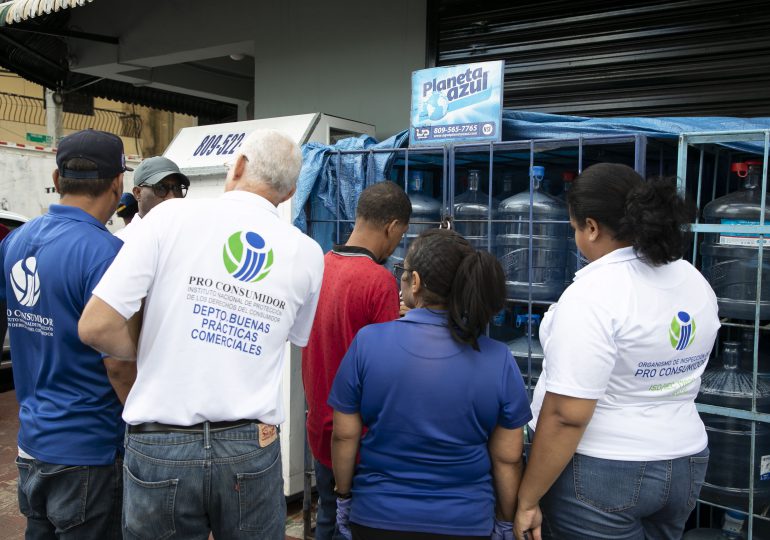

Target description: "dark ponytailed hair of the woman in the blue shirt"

left=404, top=229, right=505, bottom=350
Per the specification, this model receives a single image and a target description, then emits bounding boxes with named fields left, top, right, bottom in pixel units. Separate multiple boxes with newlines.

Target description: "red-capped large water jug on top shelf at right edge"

left=701, top=161, right=770, bottom=320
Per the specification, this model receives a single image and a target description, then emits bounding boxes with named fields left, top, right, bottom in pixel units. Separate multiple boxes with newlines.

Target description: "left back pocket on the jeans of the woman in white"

left=572, top=454, right=646, bottom=512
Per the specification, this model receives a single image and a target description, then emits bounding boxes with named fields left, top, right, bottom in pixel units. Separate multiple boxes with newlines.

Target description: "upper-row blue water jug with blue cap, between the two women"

left=496, top=167, right=570, bottom=301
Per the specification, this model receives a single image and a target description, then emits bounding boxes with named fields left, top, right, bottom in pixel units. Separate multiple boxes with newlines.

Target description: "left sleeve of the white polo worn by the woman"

left=541, top=289, right=617, bottom=399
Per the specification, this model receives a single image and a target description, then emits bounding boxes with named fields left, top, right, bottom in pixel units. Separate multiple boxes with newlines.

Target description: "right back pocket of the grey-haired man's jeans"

left=236, top=447, right=283, bottom=533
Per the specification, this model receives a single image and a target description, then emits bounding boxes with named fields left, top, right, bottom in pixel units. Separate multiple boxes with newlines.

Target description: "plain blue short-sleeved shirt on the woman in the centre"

left=329, top=309, right=532, bottom=536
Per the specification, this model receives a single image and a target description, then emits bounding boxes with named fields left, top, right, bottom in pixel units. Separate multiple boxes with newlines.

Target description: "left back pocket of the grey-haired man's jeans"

left=123, top=465, right=179, bottom=540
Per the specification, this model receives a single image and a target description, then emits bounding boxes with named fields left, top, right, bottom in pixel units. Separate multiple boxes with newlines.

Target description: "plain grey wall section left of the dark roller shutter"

left=249, top=0, right=426, bottom=140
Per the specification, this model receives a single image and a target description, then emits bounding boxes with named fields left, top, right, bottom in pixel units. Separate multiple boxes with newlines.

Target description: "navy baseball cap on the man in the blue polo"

left=56, top=129, right=133, bottom=180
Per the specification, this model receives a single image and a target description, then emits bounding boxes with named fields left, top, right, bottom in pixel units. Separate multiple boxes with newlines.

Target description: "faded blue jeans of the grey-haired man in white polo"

left=123, top=423, right=286, bottom=540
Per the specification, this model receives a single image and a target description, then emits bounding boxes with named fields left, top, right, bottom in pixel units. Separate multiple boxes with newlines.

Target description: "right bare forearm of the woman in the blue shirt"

left=489, top=426, right=524, bottom=521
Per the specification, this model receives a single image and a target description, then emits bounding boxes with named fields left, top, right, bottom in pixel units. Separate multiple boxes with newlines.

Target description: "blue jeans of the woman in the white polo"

left=540, top=448, right=709, bottom=540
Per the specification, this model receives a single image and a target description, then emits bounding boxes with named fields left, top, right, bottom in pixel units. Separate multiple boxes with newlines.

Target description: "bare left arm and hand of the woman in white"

left=514, top=392, right=596, bottom=540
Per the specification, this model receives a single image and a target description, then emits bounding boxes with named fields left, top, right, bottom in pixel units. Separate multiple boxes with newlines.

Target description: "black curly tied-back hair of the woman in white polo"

left=567, top=163, right=694, bottom=266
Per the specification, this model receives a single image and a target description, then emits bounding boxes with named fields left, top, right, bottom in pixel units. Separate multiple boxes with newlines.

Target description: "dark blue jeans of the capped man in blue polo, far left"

left=16, top=457, right=122, bottom=540
